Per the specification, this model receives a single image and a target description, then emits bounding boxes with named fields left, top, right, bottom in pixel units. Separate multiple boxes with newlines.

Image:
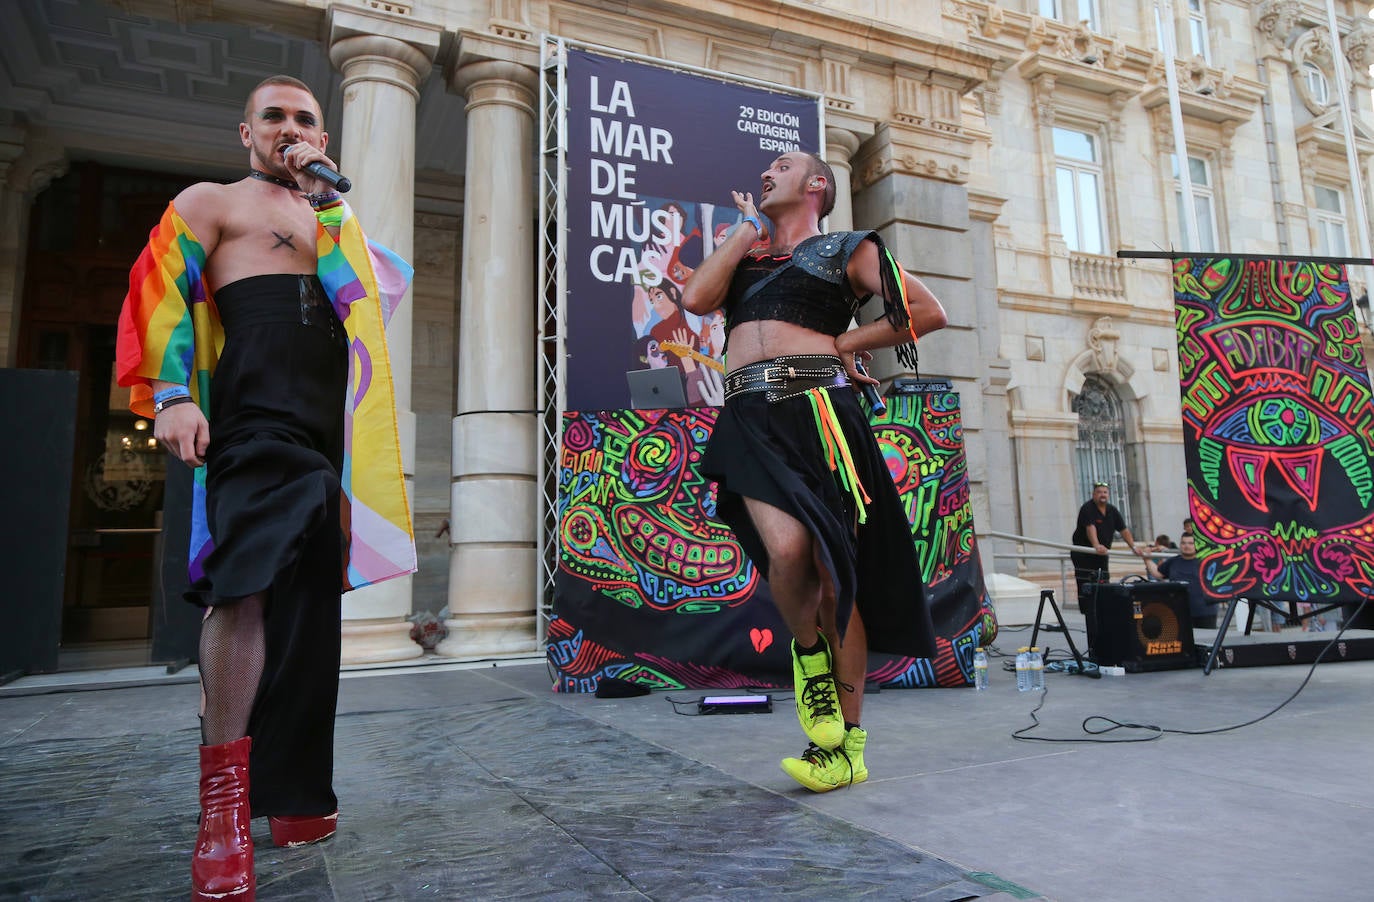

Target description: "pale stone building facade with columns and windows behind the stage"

left=0, top=0, right=1374, bottom=663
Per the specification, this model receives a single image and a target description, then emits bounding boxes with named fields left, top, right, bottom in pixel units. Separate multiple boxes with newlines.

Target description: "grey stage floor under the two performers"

left=0, top=628, right=1374, bottom=902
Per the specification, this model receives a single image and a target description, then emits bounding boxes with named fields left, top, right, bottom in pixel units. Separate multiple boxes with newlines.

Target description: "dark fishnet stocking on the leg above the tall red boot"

left=201, top=593, right=267, bottom=745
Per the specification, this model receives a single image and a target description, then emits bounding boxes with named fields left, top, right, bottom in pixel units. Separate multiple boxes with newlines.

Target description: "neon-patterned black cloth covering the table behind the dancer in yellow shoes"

left=548, top=392, right=996, bottom=692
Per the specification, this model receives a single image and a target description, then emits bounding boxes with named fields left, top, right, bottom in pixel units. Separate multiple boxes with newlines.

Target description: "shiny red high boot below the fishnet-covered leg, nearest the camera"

left=191, top=736, right=257, bottom=902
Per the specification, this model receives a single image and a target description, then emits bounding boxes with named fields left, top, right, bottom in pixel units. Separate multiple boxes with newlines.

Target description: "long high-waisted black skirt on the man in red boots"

left=187, top=274, right=348, bottom=817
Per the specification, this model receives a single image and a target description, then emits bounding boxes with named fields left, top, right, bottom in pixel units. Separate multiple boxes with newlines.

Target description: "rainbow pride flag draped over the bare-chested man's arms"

left=115, top=205, right=415, bottom=591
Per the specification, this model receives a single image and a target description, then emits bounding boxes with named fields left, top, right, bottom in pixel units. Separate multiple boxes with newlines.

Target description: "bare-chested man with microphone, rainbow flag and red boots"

left=117, top=76, right=415, bottom=902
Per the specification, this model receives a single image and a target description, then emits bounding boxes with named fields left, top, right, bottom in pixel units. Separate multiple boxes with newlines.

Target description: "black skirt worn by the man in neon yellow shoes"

left=702, top=386, right=936, bottom=657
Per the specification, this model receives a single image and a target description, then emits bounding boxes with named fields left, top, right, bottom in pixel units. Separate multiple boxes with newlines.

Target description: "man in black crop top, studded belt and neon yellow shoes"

left=683, top=153, right=945, bottom=792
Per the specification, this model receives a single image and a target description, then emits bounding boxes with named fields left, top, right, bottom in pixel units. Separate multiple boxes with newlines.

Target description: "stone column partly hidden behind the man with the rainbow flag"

left=330, top=7, right=441, bottom=664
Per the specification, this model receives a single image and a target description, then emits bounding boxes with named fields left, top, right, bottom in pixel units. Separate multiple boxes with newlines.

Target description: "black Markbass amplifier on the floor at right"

left=1087, top=580, right=1197, bottom=674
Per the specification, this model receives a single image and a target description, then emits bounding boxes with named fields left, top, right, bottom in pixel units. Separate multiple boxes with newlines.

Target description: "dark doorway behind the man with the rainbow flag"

left=18, top=162, right=206, bottom=670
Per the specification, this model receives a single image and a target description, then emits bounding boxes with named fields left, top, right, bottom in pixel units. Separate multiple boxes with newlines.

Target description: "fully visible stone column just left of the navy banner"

left=437, top=33, right=540, bottom=657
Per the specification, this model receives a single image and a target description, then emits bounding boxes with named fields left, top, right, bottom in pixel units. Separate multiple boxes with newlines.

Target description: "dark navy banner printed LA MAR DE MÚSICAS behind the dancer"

left=559, top=50, right=820, bottom=410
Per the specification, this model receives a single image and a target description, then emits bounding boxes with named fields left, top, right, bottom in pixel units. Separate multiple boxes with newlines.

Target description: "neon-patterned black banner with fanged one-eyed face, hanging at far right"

left=1173, top=259, right=1374, bottom=604
